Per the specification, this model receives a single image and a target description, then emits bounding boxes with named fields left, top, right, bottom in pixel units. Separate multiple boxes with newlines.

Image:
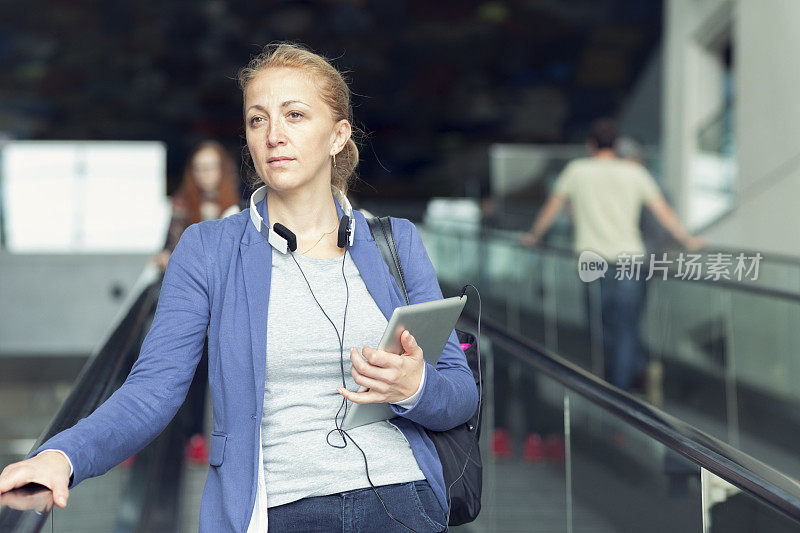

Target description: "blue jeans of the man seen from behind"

left=587, top=276, right=647, bottom=390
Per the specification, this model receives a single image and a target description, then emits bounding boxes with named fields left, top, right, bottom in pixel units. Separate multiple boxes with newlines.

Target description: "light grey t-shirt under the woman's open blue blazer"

left=261, top=250, right=425, bottom=507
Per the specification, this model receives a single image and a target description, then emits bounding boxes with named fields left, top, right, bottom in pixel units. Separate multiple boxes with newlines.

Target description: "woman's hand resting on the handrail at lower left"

left=0, top=451, right=70, bottom=508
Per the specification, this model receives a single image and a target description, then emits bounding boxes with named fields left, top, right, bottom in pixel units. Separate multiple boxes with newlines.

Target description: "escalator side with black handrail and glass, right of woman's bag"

left=456, top=314, right=800, bottom=533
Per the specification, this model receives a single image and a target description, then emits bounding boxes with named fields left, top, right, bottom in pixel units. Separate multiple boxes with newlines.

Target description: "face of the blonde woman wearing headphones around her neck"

left=244, top=68, right=350, bottom=191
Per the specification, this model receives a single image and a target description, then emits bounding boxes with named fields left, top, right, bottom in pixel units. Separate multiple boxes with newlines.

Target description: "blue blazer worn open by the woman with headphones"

left=31, top=193, right=478, bottom=532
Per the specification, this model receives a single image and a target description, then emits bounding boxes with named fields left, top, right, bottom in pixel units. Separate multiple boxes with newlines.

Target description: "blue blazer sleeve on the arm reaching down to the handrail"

left=28, top=224, right=210, bottom=488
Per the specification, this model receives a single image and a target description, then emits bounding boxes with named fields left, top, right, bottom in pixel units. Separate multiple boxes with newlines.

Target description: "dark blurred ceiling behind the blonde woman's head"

left=0, top=0, right=662, bottom=196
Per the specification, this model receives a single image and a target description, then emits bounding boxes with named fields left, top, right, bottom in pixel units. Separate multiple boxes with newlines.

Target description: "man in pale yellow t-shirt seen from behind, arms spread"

left=520, top=119, right=704, bottom=390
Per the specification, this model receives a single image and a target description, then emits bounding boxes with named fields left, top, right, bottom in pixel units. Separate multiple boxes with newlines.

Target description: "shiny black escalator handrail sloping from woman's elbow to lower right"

left=462, top=310, right=800, bottom=522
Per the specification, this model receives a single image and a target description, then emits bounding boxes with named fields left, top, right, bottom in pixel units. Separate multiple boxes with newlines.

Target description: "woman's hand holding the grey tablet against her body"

left=336, top=330, right=425, bottom=403
